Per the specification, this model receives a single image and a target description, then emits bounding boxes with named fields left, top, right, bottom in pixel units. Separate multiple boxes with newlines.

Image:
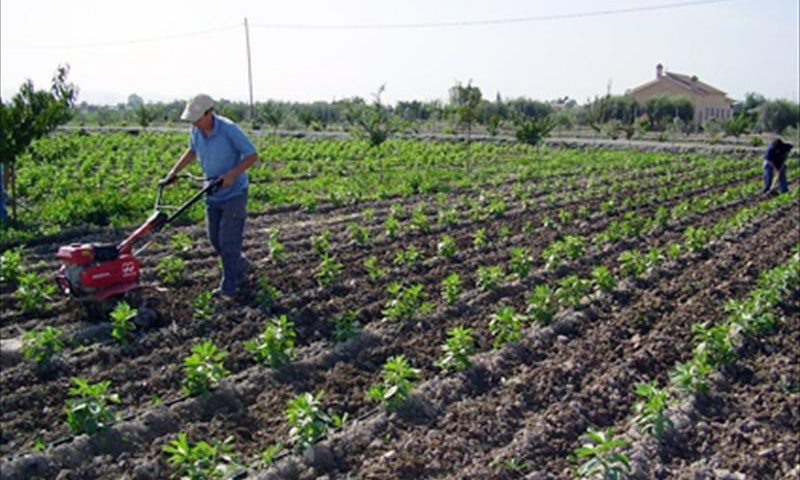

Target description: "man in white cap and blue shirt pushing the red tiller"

left=165, top=94, right=258, bottom=297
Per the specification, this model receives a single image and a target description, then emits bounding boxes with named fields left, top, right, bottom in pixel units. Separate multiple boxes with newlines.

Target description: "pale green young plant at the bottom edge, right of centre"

left=573, top=428, right=630, bottom=480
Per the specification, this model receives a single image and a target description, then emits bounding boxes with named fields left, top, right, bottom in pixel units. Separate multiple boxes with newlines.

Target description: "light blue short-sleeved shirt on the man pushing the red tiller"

left=189, top=113, right=256, bottom=204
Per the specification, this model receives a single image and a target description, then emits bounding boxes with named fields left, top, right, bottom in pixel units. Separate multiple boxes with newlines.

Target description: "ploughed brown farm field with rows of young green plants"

left=0, top=133, right=800, bottom=479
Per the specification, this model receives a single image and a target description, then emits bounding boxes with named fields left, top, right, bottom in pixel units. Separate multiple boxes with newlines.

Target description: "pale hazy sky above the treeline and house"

left=0, top=0, right=800, bottom=104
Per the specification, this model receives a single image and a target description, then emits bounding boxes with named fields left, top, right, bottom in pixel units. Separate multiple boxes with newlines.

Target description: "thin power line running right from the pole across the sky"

left=250, top=0, right=736, bottom=30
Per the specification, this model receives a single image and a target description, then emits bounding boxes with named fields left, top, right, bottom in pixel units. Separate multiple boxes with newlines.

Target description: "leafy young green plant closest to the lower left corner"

left=65, top=377, right=119, bottom=434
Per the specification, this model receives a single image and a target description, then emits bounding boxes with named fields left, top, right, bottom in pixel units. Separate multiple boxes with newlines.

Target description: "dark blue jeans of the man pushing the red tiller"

left=206, top=192, right=250, bottom=295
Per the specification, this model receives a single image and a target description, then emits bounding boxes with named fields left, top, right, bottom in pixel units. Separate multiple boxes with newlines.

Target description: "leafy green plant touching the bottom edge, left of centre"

left=161, top=432, right=239, bottom=480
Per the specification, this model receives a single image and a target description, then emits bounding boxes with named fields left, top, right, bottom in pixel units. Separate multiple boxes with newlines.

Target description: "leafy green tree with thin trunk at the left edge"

left=0, top=65, right=78, bottom=220
